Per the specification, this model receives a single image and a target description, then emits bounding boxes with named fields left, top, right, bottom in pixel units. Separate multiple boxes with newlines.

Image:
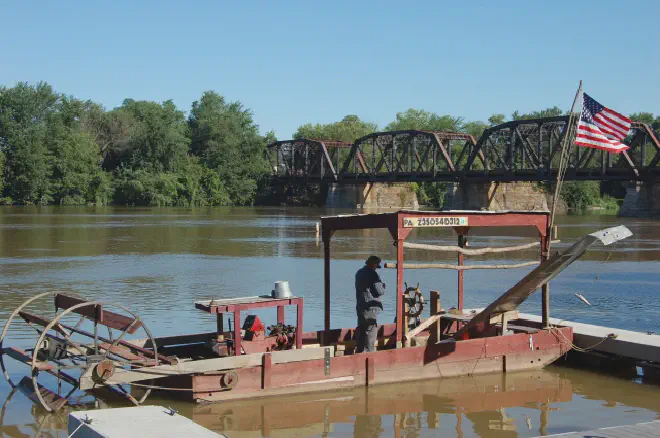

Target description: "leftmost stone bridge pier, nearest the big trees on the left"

left=325, top=183, right=419, bottom=209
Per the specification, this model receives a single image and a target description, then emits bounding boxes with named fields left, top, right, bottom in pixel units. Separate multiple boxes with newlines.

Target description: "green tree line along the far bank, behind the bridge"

left=0, top=82, right=660, bottom=206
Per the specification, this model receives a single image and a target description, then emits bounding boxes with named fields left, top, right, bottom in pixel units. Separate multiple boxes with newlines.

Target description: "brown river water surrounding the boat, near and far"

left=0, top=207, right=660, bottom=438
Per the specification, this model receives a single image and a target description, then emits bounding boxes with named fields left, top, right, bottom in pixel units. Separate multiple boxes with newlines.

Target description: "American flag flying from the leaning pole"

left=575, top=93, right=630, bottom=154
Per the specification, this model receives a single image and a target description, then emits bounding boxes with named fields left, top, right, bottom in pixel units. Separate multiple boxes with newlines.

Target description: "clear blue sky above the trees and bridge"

left=0, top=0, right=660, bottom=139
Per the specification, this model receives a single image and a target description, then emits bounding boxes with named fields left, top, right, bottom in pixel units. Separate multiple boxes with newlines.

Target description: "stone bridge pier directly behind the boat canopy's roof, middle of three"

left=443, top=182, right=552, bottom=211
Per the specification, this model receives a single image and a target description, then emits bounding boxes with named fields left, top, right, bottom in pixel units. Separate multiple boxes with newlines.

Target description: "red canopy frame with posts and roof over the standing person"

left=321, top=210, right=550, bottom=346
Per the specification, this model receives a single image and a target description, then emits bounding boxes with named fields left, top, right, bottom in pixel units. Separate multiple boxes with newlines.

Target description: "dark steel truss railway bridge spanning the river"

left=267, top=116, right=660, bottom=184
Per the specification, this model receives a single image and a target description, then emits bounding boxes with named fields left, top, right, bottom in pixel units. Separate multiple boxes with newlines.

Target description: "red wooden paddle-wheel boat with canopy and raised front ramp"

left=0, top=210, right=631, bottom=411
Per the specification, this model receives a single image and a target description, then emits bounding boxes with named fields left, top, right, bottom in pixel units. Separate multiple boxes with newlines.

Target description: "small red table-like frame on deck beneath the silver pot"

left=195, top=297, right=303, bottom=355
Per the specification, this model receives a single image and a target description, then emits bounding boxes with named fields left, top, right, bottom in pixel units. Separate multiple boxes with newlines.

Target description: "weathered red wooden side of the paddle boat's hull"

left=189, top=327, right=573, bottom=401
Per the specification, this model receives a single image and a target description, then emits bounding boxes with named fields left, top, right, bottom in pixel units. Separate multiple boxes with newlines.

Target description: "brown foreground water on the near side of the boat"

left=0, top=367, right=660, bottom=438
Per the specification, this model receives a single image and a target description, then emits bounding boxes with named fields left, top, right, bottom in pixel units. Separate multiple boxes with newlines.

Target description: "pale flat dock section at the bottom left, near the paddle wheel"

left=68, top=406, right=227, bottom=438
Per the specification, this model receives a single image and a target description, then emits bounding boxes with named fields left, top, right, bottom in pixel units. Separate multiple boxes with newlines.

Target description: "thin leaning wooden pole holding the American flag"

left=541, top=81, right=582, bottom=329
